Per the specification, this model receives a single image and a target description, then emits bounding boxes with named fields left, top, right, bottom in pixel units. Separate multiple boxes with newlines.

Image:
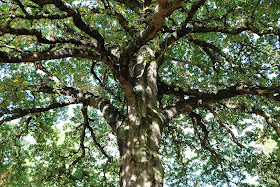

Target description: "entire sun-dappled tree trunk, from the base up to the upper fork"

left=117, top=53, right=164, bottom=187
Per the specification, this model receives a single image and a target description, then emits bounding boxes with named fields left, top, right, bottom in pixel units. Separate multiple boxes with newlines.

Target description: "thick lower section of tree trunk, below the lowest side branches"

left=118, top=112, right=163, bottom=187
